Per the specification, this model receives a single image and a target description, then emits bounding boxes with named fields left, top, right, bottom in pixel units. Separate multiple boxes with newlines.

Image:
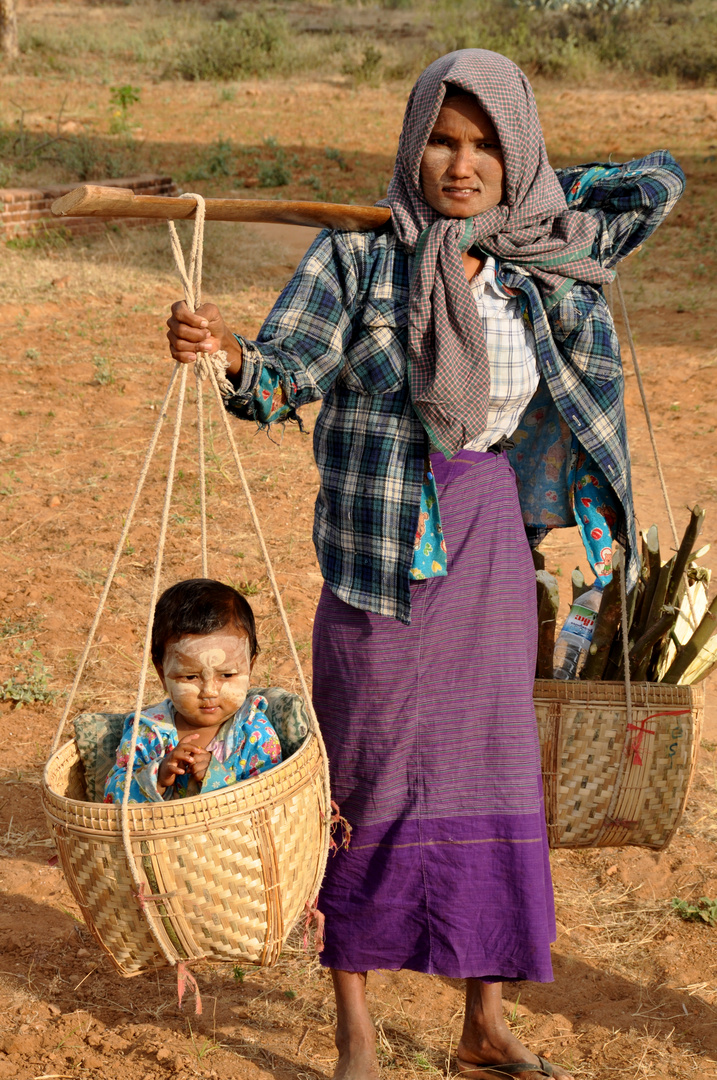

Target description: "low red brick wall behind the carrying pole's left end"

left=0, top=174, right=180, bottom=240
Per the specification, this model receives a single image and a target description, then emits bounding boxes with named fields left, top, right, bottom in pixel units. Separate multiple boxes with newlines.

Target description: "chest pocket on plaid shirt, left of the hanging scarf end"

left=340, top=298, right=408, bottom=395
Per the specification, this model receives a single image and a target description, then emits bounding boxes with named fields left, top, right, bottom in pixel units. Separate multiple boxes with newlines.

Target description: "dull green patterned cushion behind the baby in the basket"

left=75, top=686, right=309, bottom=802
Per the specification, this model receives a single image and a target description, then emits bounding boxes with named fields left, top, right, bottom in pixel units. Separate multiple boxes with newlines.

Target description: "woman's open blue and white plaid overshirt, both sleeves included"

left=227, top=150, right=685, bottom=623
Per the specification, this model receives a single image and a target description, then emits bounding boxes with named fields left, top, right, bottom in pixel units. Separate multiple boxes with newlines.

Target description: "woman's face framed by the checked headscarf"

left=421, top=94, right=504, bottom=217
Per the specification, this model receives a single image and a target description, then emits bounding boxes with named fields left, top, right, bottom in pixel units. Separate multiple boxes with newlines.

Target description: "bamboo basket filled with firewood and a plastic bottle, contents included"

left=535, top=507, right=704, bottom=849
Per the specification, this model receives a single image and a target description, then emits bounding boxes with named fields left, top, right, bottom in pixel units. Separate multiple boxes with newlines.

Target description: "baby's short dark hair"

left=152, top=578, right=259, bottom=664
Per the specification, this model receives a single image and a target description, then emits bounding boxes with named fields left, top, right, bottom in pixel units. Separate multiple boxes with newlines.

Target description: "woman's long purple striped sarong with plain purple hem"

left=313, top=450, right=555, bottom=982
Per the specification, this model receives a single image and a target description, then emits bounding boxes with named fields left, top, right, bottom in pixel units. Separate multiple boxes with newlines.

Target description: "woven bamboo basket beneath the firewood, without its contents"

left=533, top=679, right=704, bottom=850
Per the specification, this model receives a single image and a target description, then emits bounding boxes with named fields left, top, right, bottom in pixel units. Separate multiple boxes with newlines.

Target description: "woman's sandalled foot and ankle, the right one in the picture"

left=457, top=978, right=573, bottom=1080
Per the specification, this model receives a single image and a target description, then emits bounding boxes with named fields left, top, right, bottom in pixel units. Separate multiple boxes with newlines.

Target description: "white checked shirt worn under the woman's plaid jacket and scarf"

left=465, top=255, right=539, bottom=450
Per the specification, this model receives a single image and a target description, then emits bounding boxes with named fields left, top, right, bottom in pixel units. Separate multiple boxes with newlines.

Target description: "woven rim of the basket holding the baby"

left=40, top=731, right=316, bottom=835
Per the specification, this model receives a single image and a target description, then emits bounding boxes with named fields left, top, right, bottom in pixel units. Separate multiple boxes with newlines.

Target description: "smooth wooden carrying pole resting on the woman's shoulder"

left=52, top=184, right=391, bottom=232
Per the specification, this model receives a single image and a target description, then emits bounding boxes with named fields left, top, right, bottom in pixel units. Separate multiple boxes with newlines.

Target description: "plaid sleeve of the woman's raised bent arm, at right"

left=556, top=150, right=685, bottom=268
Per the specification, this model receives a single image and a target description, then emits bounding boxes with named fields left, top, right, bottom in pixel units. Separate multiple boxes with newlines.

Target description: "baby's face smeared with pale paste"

left=157, top=626, right=252, bottom=728
